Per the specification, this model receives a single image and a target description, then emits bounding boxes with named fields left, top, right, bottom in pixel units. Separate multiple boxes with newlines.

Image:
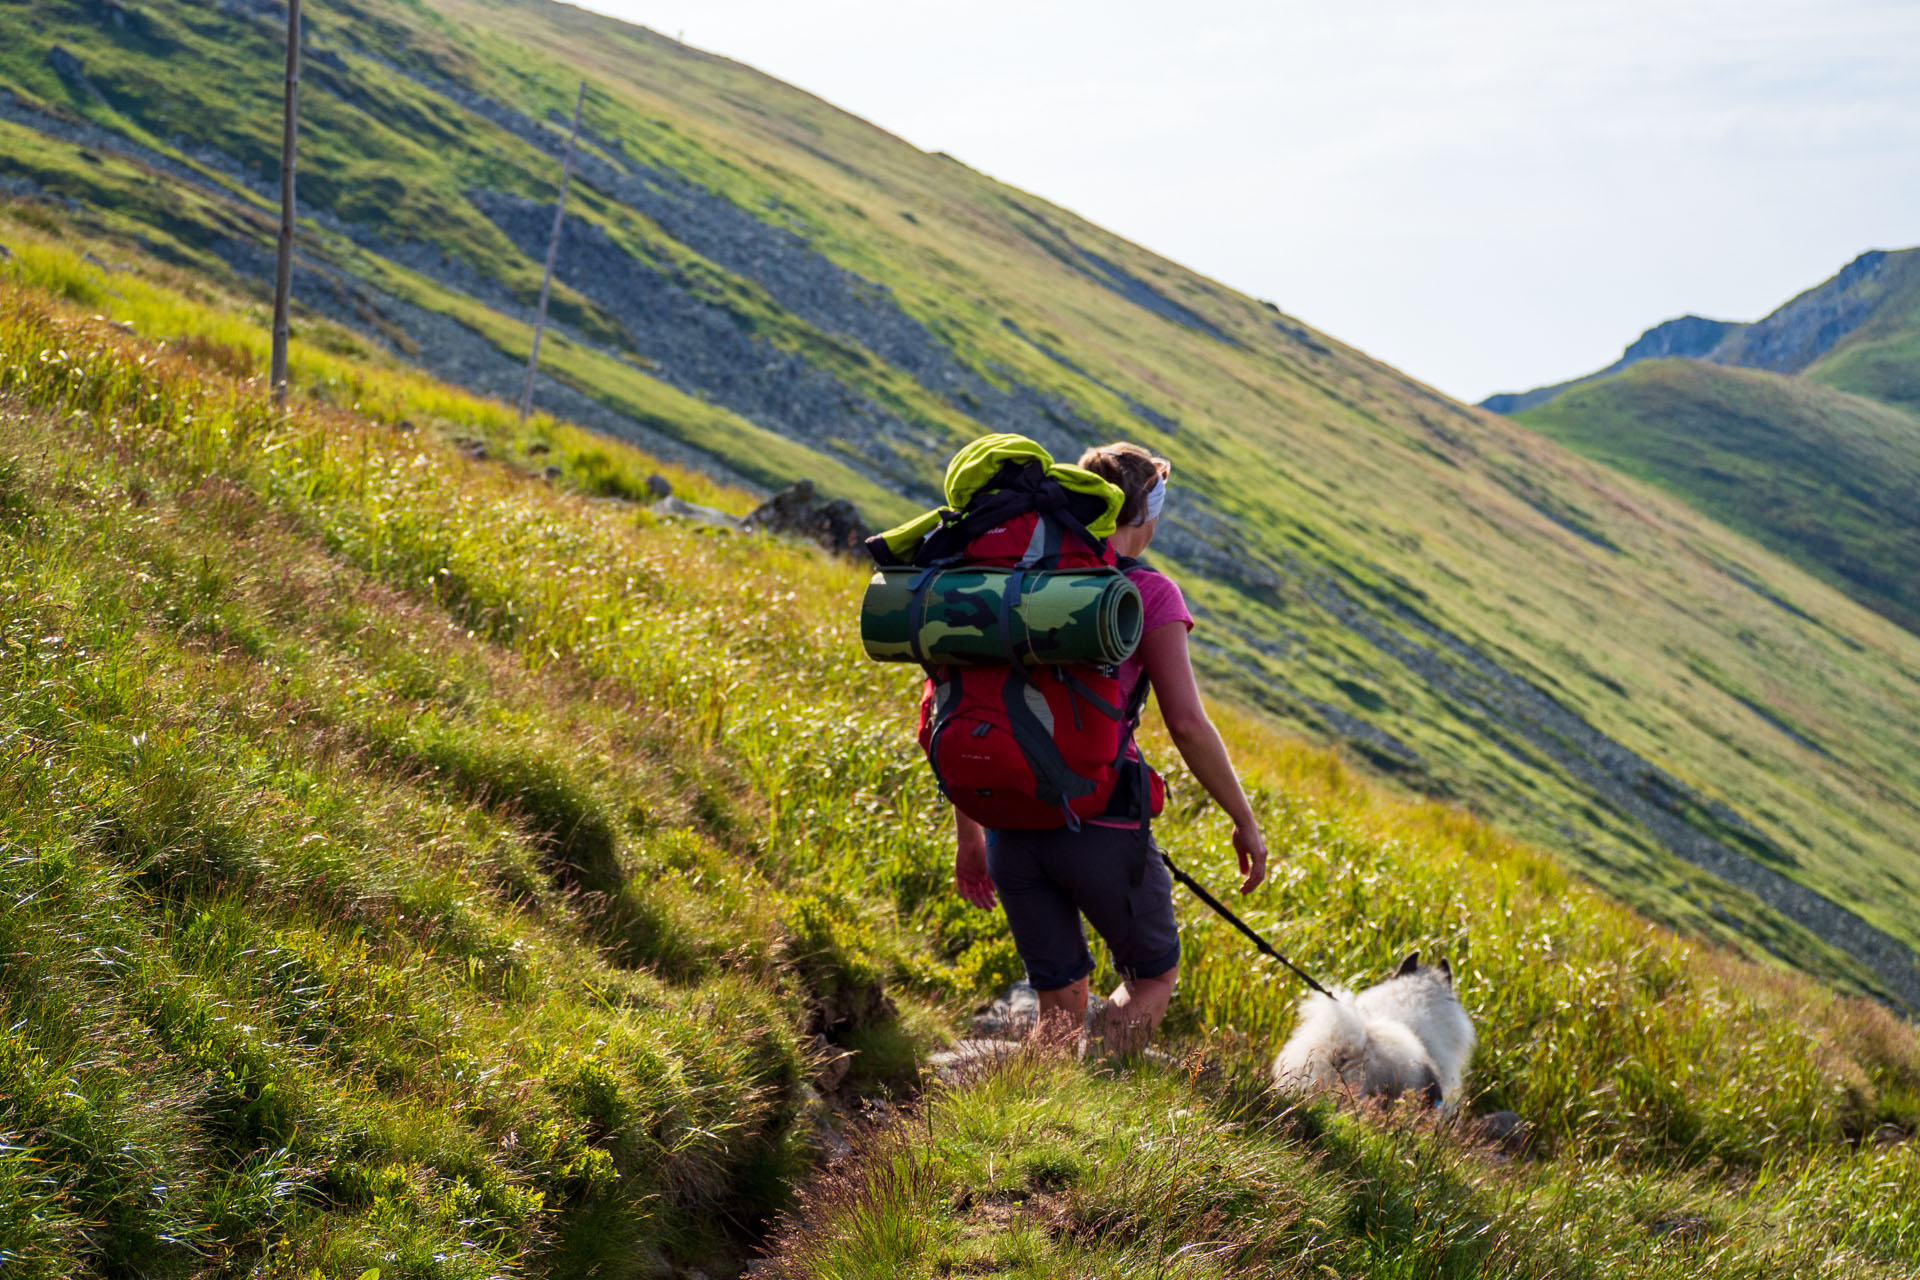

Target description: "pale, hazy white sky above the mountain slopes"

left=568, top=0, right=1920, bottom=401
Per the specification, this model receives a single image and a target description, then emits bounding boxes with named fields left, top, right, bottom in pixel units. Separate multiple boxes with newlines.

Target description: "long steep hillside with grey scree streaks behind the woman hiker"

left=0, top=0, right=1920, bottom=1028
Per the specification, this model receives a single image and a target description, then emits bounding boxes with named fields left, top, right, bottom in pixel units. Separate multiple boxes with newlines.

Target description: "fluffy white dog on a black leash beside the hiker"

left=1273, top=952, right=1475, bottom=1109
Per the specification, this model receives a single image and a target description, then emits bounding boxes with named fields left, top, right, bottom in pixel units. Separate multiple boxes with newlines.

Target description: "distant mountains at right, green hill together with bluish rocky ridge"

left=1486, top=249, right=1920, bottom=644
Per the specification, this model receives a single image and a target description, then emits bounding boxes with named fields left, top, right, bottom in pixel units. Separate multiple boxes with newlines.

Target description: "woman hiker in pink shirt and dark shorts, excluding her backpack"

left=954, top=443, right=1267, bottom=1054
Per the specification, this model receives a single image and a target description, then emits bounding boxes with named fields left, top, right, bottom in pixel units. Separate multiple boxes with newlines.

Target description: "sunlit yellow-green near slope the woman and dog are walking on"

left=0, top=223, right=1920, bottom=1280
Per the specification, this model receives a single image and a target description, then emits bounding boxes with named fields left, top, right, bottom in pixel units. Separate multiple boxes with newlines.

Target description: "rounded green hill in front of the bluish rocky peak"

left=1519, top=361, right=1920, bottom=631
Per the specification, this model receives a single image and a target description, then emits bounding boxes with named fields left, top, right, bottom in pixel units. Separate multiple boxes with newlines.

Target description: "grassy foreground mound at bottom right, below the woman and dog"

left=774, top=1052, right=1920, bottom=1280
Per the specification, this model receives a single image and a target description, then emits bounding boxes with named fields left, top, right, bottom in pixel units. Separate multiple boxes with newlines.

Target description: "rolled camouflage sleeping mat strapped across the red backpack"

left=860, top=568, right=1142, bottom=666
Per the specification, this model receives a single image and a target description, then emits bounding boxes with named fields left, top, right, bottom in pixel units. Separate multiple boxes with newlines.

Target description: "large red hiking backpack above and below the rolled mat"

left=876, top=461, right=1164, bottom=831
